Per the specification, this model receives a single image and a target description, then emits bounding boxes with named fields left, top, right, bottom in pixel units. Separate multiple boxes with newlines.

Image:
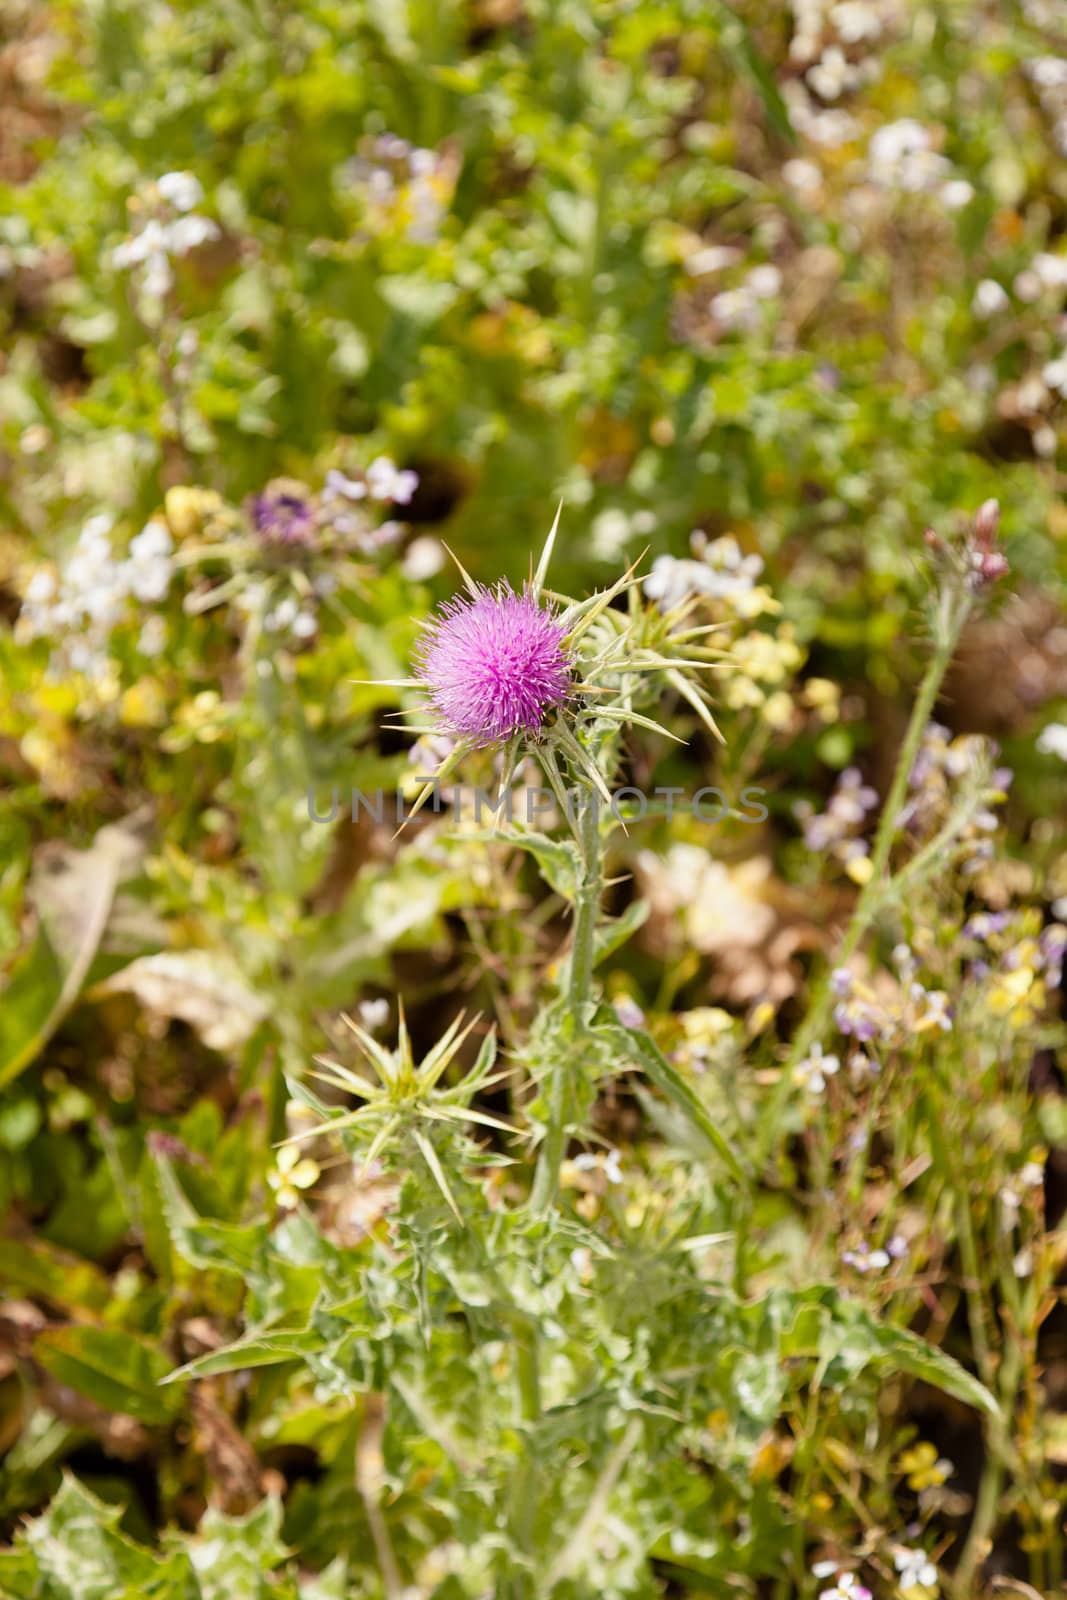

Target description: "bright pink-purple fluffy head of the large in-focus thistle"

left=416, top=584, right=571, bottom=746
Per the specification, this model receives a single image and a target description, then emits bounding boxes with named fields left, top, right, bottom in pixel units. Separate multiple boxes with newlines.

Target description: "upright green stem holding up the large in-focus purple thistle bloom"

left=530, top=790, right=603, bottom=1213
